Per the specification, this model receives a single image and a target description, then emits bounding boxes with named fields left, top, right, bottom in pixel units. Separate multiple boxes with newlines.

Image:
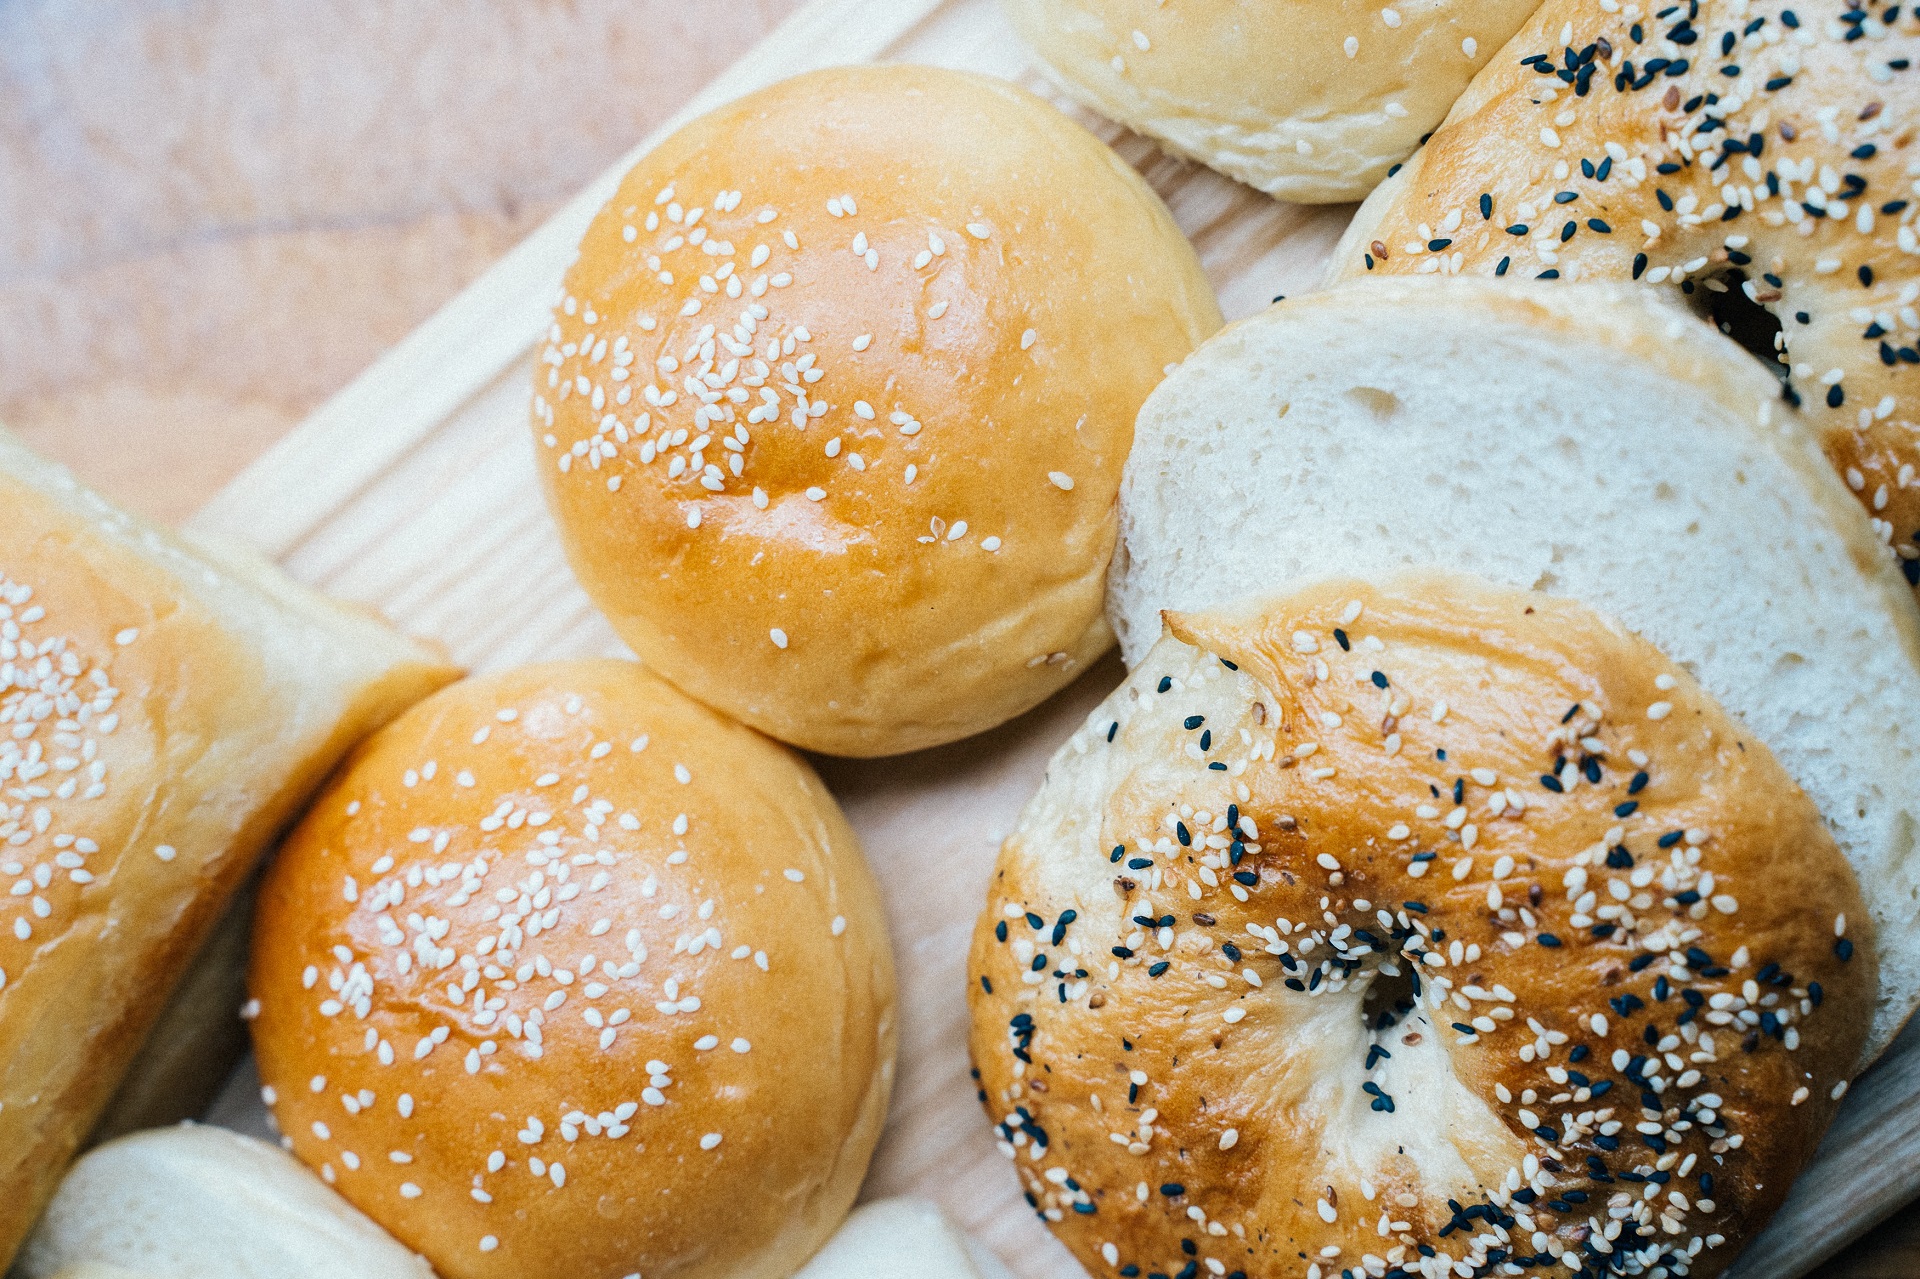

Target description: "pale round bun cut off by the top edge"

left=1000, top=0, right=1534, bottom=204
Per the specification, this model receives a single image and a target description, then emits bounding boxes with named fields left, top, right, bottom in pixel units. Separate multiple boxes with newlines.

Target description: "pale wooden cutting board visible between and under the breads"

left=188, top=0, right=1920, bottom=1279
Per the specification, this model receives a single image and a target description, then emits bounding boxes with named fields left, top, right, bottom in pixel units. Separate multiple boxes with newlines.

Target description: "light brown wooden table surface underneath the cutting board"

left=0, top=0, right=1920, bottom=1279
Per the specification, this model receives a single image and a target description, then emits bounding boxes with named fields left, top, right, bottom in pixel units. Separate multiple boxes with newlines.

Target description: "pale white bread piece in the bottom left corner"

left=15, top=1123, right=434, bottom=1279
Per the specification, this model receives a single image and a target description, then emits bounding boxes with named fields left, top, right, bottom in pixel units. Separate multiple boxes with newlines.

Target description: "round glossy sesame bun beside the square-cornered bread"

left=250, top=661, right=895, bottom=1279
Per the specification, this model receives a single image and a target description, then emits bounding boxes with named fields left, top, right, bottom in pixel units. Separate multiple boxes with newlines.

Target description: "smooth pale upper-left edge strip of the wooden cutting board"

left=186, top=0, right=945, bottom=559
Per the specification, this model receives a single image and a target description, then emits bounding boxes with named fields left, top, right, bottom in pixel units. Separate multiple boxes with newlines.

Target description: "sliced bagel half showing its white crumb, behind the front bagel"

left=1110, top=278, right=1920, bottom=1056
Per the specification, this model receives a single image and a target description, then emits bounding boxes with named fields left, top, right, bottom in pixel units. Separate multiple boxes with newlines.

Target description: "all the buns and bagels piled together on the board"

left=0, top=0, right=1920, bottom=1279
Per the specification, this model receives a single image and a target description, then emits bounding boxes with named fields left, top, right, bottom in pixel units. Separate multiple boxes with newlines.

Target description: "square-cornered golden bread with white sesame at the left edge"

left=0, top=432, right=453, bottom=1264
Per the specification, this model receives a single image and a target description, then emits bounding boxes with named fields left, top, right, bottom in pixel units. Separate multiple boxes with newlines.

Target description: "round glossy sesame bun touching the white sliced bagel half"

left=534, top=67, right=1221, bottom=755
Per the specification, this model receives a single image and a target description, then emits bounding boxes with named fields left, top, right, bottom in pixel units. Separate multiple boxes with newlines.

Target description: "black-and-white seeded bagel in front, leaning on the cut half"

left=970, top=574, right=1874, bottom=1279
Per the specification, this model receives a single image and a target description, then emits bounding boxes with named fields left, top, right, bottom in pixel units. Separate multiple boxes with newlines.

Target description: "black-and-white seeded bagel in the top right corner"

left=1334, top=0, right=1920, bottom=586
